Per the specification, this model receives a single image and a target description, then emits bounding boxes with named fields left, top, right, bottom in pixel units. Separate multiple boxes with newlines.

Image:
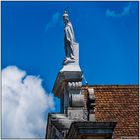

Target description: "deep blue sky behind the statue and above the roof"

left=2, top=2, right=138, bottom=111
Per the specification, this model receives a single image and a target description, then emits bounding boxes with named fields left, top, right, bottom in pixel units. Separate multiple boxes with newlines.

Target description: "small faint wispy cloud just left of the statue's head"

left=45, top=12, right=61, bottom=31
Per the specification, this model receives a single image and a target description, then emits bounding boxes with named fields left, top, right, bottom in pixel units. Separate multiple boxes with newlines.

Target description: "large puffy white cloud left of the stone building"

left=2, top=66, right=54, bottom=138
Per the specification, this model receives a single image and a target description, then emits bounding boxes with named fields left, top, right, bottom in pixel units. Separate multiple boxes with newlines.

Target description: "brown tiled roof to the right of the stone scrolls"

left=83, top=85, right=139, bottom=138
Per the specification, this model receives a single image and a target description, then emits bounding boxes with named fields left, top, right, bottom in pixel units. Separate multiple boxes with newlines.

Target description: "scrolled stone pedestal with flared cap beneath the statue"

left=53, top=64, right=84, bottom=116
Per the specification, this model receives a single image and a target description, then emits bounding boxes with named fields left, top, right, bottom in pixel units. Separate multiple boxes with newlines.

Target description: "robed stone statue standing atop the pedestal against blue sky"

left=63, top=11, right=76, bottom=64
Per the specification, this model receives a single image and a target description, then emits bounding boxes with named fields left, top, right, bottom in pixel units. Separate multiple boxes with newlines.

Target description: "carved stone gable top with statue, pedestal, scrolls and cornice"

left=46, top=12, right=115, bottom=139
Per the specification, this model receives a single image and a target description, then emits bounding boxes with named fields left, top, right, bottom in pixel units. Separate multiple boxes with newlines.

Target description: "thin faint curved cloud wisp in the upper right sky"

left=106, top=2, right=135, bottom=18
